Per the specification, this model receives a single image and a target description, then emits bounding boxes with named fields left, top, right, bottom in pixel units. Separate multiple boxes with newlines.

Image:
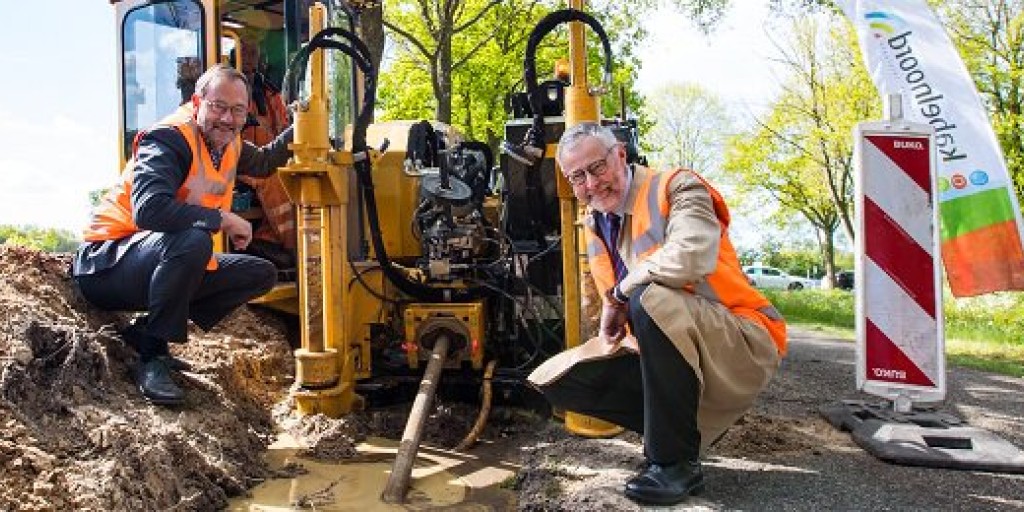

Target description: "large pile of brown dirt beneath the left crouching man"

left=0, top=246, right=293, bottom=510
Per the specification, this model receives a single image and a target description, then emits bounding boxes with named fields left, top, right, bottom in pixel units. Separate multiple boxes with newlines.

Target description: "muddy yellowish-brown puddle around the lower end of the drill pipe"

left=227, top=434, right=517, bottom=512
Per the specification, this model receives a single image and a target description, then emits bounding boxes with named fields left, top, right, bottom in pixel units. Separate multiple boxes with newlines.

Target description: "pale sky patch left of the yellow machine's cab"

left=0, top=0, right=118, bottom=232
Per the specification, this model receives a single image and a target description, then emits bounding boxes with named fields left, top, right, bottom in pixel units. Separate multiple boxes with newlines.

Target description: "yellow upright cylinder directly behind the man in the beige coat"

left=555, top=0, right=623, bottom=437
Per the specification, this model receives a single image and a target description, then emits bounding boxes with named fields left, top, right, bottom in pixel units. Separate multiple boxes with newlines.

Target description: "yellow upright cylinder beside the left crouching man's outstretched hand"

left=278, top=3, right=358, bottom=417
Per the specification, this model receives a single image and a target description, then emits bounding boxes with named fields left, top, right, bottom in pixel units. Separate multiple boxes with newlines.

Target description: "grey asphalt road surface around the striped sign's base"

left=688, top=331, right=1024, bottom=511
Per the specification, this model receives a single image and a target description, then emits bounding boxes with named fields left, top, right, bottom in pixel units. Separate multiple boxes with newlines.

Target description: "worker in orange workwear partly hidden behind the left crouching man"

left=234, top=41, right=296, bottom=268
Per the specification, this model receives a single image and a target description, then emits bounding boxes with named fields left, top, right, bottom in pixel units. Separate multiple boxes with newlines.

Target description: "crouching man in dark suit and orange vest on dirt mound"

left=73, top=65, right=292, bottom=406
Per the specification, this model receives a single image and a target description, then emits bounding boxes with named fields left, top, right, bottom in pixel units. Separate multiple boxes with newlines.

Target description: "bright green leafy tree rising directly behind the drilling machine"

left=380, top=0, right=729, bottom=140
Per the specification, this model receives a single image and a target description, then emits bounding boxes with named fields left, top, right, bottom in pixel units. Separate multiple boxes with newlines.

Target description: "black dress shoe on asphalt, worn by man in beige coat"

left=626, top=462, right=703, bottom=505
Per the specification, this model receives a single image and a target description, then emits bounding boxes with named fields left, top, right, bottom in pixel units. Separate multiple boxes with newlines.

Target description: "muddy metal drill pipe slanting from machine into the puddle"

left=381, top=335, right=449, bottom=503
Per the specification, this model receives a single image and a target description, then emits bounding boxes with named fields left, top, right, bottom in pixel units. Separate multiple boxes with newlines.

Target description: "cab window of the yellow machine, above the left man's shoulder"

left=121, top=0, right=206, bottom=160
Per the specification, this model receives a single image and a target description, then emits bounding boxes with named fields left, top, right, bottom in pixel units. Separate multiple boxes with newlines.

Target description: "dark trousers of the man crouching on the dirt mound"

left=75, top=229, right=278, bottom=342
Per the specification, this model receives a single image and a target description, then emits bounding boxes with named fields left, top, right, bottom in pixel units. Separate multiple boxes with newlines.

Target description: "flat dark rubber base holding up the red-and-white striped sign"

left=820, top=400, right=1024, bottom=473
